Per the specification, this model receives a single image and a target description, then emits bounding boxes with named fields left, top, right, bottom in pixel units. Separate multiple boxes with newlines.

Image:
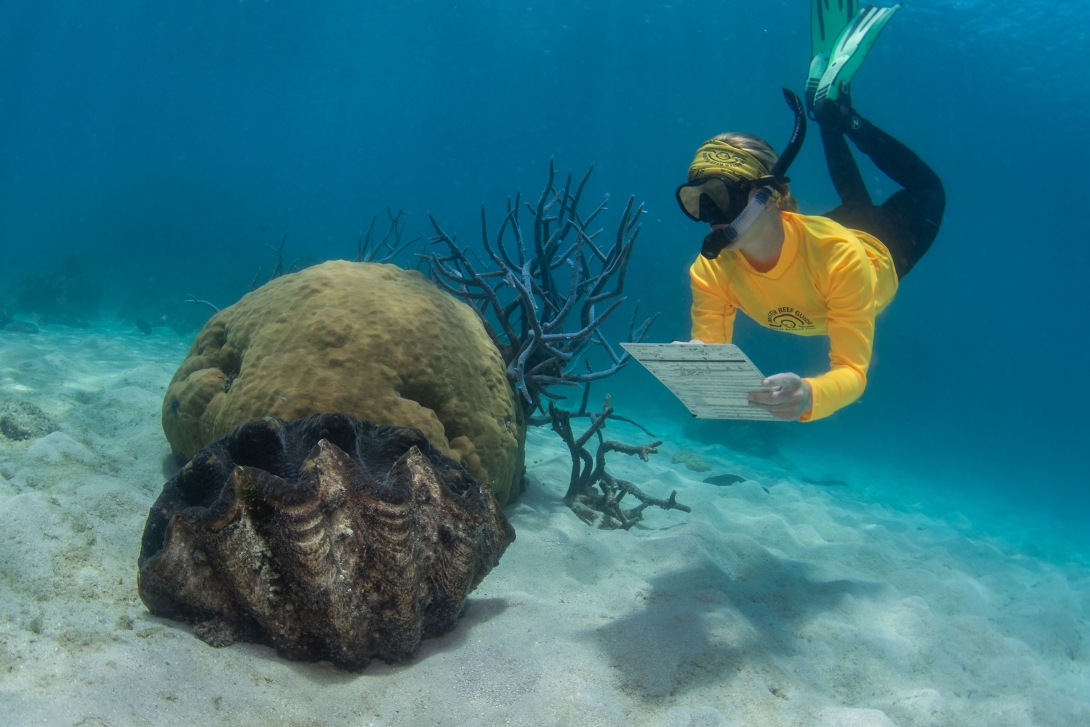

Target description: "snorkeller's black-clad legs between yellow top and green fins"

left=821, top=117, right=946, bottom=278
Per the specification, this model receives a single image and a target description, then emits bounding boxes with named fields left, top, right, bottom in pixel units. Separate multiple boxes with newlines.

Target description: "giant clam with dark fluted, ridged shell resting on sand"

left=137, top=414, right=514, bottom=668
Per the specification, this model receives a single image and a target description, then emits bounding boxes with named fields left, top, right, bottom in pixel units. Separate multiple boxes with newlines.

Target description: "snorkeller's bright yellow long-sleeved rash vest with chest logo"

left=689, top=213, right=897, bottom=422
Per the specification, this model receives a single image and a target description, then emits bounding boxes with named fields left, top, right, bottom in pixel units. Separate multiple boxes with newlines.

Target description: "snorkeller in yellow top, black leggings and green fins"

left=676, top=0, right=946, bottom=422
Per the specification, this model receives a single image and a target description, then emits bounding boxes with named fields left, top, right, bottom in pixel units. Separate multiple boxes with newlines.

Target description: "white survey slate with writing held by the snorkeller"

left=621, top=343, right=777, bottom=421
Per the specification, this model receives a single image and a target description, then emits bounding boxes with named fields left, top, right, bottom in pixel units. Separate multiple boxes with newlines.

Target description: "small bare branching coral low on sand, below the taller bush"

left=548, top=396, right=692, bottom=530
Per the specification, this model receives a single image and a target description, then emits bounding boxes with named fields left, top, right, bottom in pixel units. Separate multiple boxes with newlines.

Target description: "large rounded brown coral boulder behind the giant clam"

left=162, top=260, right=525, bottom=505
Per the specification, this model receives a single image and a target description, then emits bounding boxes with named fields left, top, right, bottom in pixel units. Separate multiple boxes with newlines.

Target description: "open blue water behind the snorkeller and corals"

left=0, top=0, right=1090, bottom=544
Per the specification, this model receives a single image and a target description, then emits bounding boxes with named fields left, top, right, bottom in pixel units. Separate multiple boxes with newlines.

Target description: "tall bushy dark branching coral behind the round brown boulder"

left=423, top=162, right=655, bottom=414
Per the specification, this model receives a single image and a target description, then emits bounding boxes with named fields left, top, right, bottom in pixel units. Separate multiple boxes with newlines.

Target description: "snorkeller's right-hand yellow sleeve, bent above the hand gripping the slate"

left=799, top=248, right=874, bottom=422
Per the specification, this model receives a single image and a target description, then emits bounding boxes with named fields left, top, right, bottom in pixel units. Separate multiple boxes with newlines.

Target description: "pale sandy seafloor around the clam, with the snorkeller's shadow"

left=0, top=324, right=1090, bottom=727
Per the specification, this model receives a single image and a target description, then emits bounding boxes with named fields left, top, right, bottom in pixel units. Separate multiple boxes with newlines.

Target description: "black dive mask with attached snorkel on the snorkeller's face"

left=675, top=88, right=807, bottom=259
